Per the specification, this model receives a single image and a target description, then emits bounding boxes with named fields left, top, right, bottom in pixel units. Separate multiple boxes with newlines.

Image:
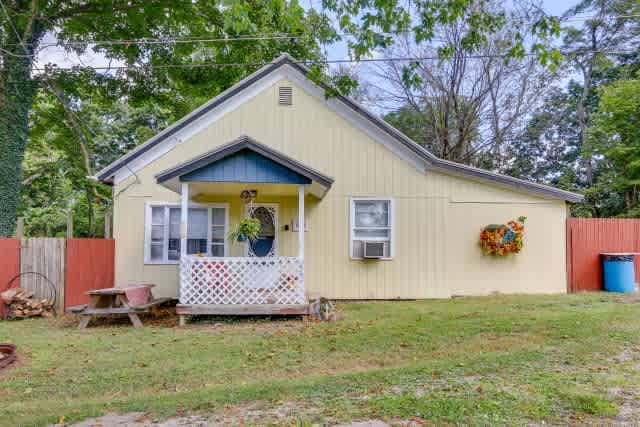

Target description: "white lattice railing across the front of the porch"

left=180, top=256, right=306, bottom=305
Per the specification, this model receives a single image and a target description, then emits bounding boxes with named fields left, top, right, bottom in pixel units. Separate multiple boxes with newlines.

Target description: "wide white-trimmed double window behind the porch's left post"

left=145, top=204, right=229, bottom=264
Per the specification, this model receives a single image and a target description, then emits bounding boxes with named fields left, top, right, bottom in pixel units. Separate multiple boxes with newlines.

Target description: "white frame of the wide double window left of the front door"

left=144, top=202, right=229, bottom=265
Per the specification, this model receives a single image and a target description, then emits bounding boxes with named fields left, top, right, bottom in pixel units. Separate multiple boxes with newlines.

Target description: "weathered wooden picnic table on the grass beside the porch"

left=69, top=288, right=171, bottom=329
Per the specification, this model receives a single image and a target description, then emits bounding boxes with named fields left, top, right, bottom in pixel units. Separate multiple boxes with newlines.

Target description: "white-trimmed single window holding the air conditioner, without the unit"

left=351, top=198, right=394, bottom=259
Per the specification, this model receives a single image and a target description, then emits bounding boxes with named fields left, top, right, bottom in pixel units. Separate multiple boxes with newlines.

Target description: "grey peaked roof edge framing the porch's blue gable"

left=156, top=135, right=333, bottom=189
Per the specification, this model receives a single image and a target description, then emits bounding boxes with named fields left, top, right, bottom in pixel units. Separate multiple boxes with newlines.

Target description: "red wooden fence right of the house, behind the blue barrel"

left=567, top=218, right=640, bottom=292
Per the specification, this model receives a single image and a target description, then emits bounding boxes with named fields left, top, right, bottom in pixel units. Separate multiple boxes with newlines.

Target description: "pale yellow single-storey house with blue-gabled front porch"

left=97, top=55, right=582, bottom=320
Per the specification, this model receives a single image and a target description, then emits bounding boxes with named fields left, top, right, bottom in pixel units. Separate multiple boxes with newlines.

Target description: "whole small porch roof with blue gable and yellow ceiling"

left=156, top=136, right=333, bottom=198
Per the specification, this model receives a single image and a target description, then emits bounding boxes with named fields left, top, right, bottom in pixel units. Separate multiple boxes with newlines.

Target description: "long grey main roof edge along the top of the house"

left=96, top=53, right=584, bottom=202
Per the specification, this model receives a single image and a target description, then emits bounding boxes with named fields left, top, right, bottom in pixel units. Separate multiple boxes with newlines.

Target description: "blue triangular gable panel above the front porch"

left=180, top=148, right=311, bottom=184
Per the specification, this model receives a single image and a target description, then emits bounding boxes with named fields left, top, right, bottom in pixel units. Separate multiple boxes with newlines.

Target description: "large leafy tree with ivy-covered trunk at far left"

left=0, top=0, right=333, bottom=236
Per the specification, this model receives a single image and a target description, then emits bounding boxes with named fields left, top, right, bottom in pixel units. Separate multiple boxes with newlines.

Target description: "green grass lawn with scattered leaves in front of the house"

left=0, top=293, right=640, bottom=426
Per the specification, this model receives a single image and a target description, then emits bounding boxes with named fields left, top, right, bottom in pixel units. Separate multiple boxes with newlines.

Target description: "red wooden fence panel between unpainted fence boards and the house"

left=64, top=239, right=115, bottom=308
